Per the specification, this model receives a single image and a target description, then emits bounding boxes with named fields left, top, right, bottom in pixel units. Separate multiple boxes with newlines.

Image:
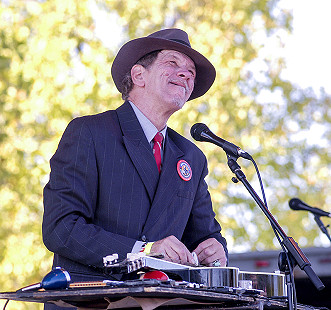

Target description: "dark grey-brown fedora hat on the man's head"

left=111, top=28, right=216, bottom=100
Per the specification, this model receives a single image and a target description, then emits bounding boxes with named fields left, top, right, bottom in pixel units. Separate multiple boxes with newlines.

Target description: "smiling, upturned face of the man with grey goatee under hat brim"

left=145, top=50, right=196, bottom=113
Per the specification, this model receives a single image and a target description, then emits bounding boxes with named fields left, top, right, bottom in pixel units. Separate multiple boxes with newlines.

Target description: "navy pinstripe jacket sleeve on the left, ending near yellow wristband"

left=42, top=118, right=136, bottom=267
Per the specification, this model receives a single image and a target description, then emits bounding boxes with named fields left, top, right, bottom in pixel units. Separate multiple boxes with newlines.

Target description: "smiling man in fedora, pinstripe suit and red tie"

left=43, top=29, right=227, bottom=308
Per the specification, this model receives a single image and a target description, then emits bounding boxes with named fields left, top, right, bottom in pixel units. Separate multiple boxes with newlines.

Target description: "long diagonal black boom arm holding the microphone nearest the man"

left=227, top=154, right=325, bottom=291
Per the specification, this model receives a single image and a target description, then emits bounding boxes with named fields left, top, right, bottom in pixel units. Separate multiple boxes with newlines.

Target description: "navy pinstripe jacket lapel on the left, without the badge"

left=116, top=102, right=159, bottom=201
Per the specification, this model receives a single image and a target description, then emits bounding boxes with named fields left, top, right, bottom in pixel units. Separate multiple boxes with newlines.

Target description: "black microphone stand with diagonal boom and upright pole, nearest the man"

left=226, top=153, right=325, bottom=309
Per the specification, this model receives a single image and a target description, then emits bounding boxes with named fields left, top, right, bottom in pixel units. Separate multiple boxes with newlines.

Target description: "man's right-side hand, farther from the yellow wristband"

left=194, top=238, right=226, bottom=267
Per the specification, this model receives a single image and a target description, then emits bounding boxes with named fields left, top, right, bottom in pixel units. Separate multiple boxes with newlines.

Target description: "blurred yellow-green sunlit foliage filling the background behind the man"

left=0, top=0, right=331, bottom=309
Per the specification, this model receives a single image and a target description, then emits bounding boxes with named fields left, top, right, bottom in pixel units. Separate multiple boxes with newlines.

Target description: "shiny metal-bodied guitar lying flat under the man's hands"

left=103, top=253, right=286, bottom=297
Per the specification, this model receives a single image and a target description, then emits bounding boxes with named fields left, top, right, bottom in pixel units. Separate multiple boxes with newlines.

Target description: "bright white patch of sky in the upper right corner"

left=280, top=0, right=331, bottom=94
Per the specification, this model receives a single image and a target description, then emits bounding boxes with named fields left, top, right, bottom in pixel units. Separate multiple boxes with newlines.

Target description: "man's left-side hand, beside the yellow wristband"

left=151, top=236, right=195, bottom=265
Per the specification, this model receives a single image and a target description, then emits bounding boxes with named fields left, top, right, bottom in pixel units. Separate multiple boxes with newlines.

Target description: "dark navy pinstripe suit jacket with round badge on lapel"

left=42, top=102, right=226, bottom=275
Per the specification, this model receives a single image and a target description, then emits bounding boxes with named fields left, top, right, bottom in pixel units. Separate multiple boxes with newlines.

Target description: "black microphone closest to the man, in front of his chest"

left=191, top=123, right=252, bottom=160
